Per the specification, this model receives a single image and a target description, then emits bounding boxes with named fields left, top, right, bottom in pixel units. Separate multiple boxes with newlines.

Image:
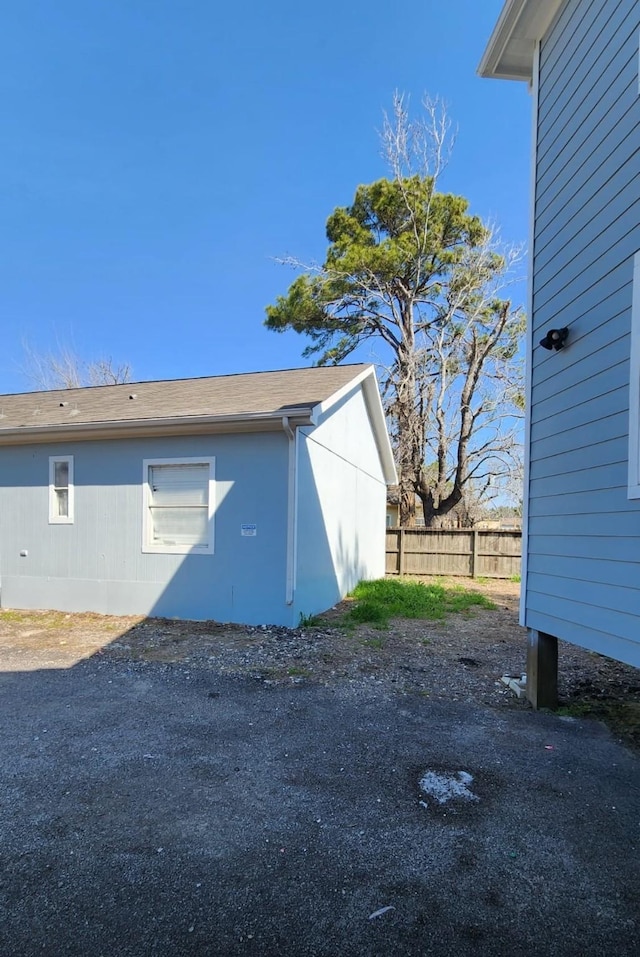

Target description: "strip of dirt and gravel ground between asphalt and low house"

left=0, top=579, right=640, bottom=748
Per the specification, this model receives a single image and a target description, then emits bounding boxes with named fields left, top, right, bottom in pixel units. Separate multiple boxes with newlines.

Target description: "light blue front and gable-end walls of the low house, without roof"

left=0, top=385, right=386, bottom=626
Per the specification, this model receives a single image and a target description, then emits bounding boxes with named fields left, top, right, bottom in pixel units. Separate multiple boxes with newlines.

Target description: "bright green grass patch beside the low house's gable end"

left=345, top=578, right=496, bottom=627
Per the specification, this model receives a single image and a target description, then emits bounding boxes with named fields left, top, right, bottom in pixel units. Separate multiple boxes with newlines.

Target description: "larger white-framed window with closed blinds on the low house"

left=142, top=458, right=214, bottom=554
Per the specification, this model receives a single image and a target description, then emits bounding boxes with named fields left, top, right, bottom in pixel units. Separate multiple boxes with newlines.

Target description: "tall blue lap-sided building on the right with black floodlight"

left=479, top=0, right=640, bottom=704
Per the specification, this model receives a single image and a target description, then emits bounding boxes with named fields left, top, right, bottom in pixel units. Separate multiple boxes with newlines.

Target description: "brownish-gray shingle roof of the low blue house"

left=0, top=365, right=371, bottom=434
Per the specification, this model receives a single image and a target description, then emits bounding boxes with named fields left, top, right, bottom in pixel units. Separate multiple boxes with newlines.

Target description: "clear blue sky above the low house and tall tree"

left=0, top=0, right=531, bottom=392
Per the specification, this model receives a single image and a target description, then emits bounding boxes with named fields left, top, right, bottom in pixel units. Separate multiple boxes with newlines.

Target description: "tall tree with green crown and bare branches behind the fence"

left=266, top=95, right=524, bottom=526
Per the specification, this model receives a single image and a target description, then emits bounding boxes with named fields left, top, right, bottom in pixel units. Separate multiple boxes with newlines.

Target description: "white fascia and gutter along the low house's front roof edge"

left=0, top=406, right=313, bottom=446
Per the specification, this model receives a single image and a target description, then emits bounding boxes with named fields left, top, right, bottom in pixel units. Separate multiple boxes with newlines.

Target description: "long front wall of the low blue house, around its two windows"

left=0, top=433, right=291, bottom=624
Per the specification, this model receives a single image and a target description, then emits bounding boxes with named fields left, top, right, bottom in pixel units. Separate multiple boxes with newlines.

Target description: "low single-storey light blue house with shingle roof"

left=0, top=365, right=396, bottom=626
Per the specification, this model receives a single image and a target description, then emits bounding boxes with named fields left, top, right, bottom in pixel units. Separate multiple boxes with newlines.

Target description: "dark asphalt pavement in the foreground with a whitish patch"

left=0, top=656, right=640, bottom=957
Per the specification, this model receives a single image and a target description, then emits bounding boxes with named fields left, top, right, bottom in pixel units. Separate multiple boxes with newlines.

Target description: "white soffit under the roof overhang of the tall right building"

left=478, top=0, right=564, bottom=81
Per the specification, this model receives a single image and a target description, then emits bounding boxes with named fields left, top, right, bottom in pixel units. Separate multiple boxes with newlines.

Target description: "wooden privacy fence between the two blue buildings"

left=386, top=528, right=522, bottom=578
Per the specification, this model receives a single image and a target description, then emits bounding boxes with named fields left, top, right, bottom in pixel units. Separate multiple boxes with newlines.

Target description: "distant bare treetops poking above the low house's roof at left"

left=22, top=342, right=131, bottom=391
